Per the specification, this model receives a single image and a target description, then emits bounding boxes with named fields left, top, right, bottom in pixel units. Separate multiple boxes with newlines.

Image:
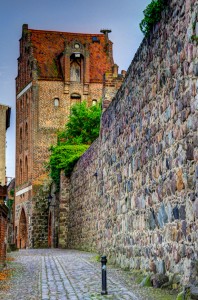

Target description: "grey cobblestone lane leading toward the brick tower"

left=0, top=249, right=176, bottom=300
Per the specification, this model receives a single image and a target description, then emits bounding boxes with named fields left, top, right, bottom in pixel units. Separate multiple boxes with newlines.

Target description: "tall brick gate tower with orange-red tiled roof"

left=15, top=24, right=120, bottom=248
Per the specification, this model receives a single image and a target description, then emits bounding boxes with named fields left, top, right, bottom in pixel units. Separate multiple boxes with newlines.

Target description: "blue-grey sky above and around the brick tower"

left=0, top=0, right=151, bottom=177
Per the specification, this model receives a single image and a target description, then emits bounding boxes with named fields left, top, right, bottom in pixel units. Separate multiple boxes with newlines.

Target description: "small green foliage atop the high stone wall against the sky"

left=140, top=0, right=166, bottom=36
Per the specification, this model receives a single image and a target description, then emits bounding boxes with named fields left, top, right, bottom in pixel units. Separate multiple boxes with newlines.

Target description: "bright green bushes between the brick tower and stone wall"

left=49, top=102, right=101, bottom=189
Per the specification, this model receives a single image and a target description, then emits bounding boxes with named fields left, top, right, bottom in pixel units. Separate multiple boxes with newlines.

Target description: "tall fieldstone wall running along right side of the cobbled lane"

left=60, top=0, right=198, bottom=282
